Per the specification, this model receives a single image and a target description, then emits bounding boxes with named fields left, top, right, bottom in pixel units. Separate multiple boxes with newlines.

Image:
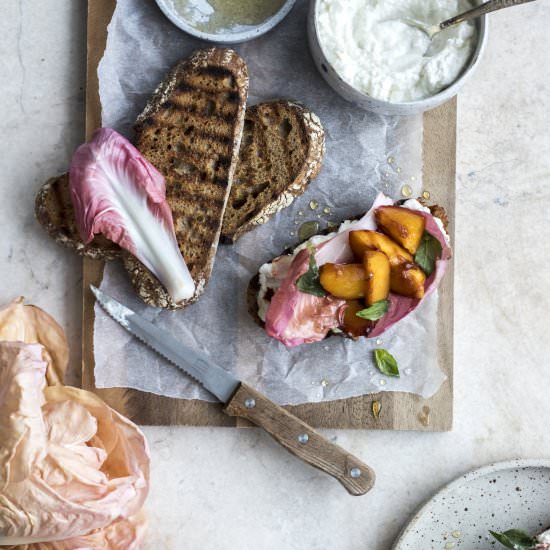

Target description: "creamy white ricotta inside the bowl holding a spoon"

left=317, top=0, right=477, bottom=103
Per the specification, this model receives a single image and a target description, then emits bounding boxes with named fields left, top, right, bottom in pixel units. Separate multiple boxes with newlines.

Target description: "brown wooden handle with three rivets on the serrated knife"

left=224, top=384, right=375, bottom=496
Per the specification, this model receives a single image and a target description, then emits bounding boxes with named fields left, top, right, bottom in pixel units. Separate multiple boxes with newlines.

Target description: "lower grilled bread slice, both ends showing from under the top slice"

left=35, top=100, right=324, bottom=260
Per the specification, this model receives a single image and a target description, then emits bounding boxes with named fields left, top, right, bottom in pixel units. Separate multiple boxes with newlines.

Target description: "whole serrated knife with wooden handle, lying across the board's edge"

left=90, top=285, right=375, bottom=496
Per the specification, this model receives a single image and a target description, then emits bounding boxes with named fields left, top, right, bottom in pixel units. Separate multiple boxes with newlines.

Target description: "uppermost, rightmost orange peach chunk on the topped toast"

left=374, top=206, right=426, bottom=254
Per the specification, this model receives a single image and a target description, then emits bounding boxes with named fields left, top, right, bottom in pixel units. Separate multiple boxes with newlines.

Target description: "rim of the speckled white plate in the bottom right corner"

left=391, top=458, right=550, bottom=550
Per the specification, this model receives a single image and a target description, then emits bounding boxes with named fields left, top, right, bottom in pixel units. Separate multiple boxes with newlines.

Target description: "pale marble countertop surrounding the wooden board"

left=0, top=0, right=550, bottom=550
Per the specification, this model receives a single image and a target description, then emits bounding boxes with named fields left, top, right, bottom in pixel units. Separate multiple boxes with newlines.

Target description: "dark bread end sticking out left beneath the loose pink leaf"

left=35, top=174, right=121, bottom=260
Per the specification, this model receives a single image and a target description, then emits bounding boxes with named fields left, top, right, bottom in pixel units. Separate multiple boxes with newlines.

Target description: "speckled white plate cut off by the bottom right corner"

left=393, top=459, right=550, bottom=550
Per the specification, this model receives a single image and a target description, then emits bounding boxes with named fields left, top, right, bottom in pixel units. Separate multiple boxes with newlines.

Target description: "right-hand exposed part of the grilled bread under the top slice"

left=222, top=101, right=325, bottom=241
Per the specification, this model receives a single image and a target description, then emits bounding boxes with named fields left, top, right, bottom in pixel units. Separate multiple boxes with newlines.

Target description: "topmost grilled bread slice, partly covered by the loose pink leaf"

left=123, top=48, right=248, bottom=308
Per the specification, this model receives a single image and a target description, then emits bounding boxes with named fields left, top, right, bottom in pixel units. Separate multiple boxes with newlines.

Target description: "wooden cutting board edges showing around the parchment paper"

left=82, top=0, right=456, bottom=431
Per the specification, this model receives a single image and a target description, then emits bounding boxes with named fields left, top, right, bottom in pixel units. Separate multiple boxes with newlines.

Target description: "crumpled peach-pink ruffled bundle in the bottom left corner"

left=0, top=300, right=149, bottom=550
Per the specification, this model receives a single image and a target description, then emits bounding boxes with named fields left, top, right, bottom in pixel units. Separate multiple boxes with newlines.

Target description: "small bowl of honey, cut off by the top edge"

left=156, top=0, right=296, bottom=44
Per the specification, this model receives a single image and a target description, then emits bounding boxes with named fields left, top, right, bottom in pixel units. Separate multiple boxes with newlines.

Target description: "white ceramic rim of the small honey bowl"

left=156, top=0, right=296, bottom=44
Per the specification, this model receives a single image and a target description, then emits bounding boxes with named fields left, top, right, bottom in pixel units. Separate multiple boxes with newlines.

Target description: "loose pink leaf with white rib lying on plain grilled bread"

left=69, top=128, right=195, bottom=302
